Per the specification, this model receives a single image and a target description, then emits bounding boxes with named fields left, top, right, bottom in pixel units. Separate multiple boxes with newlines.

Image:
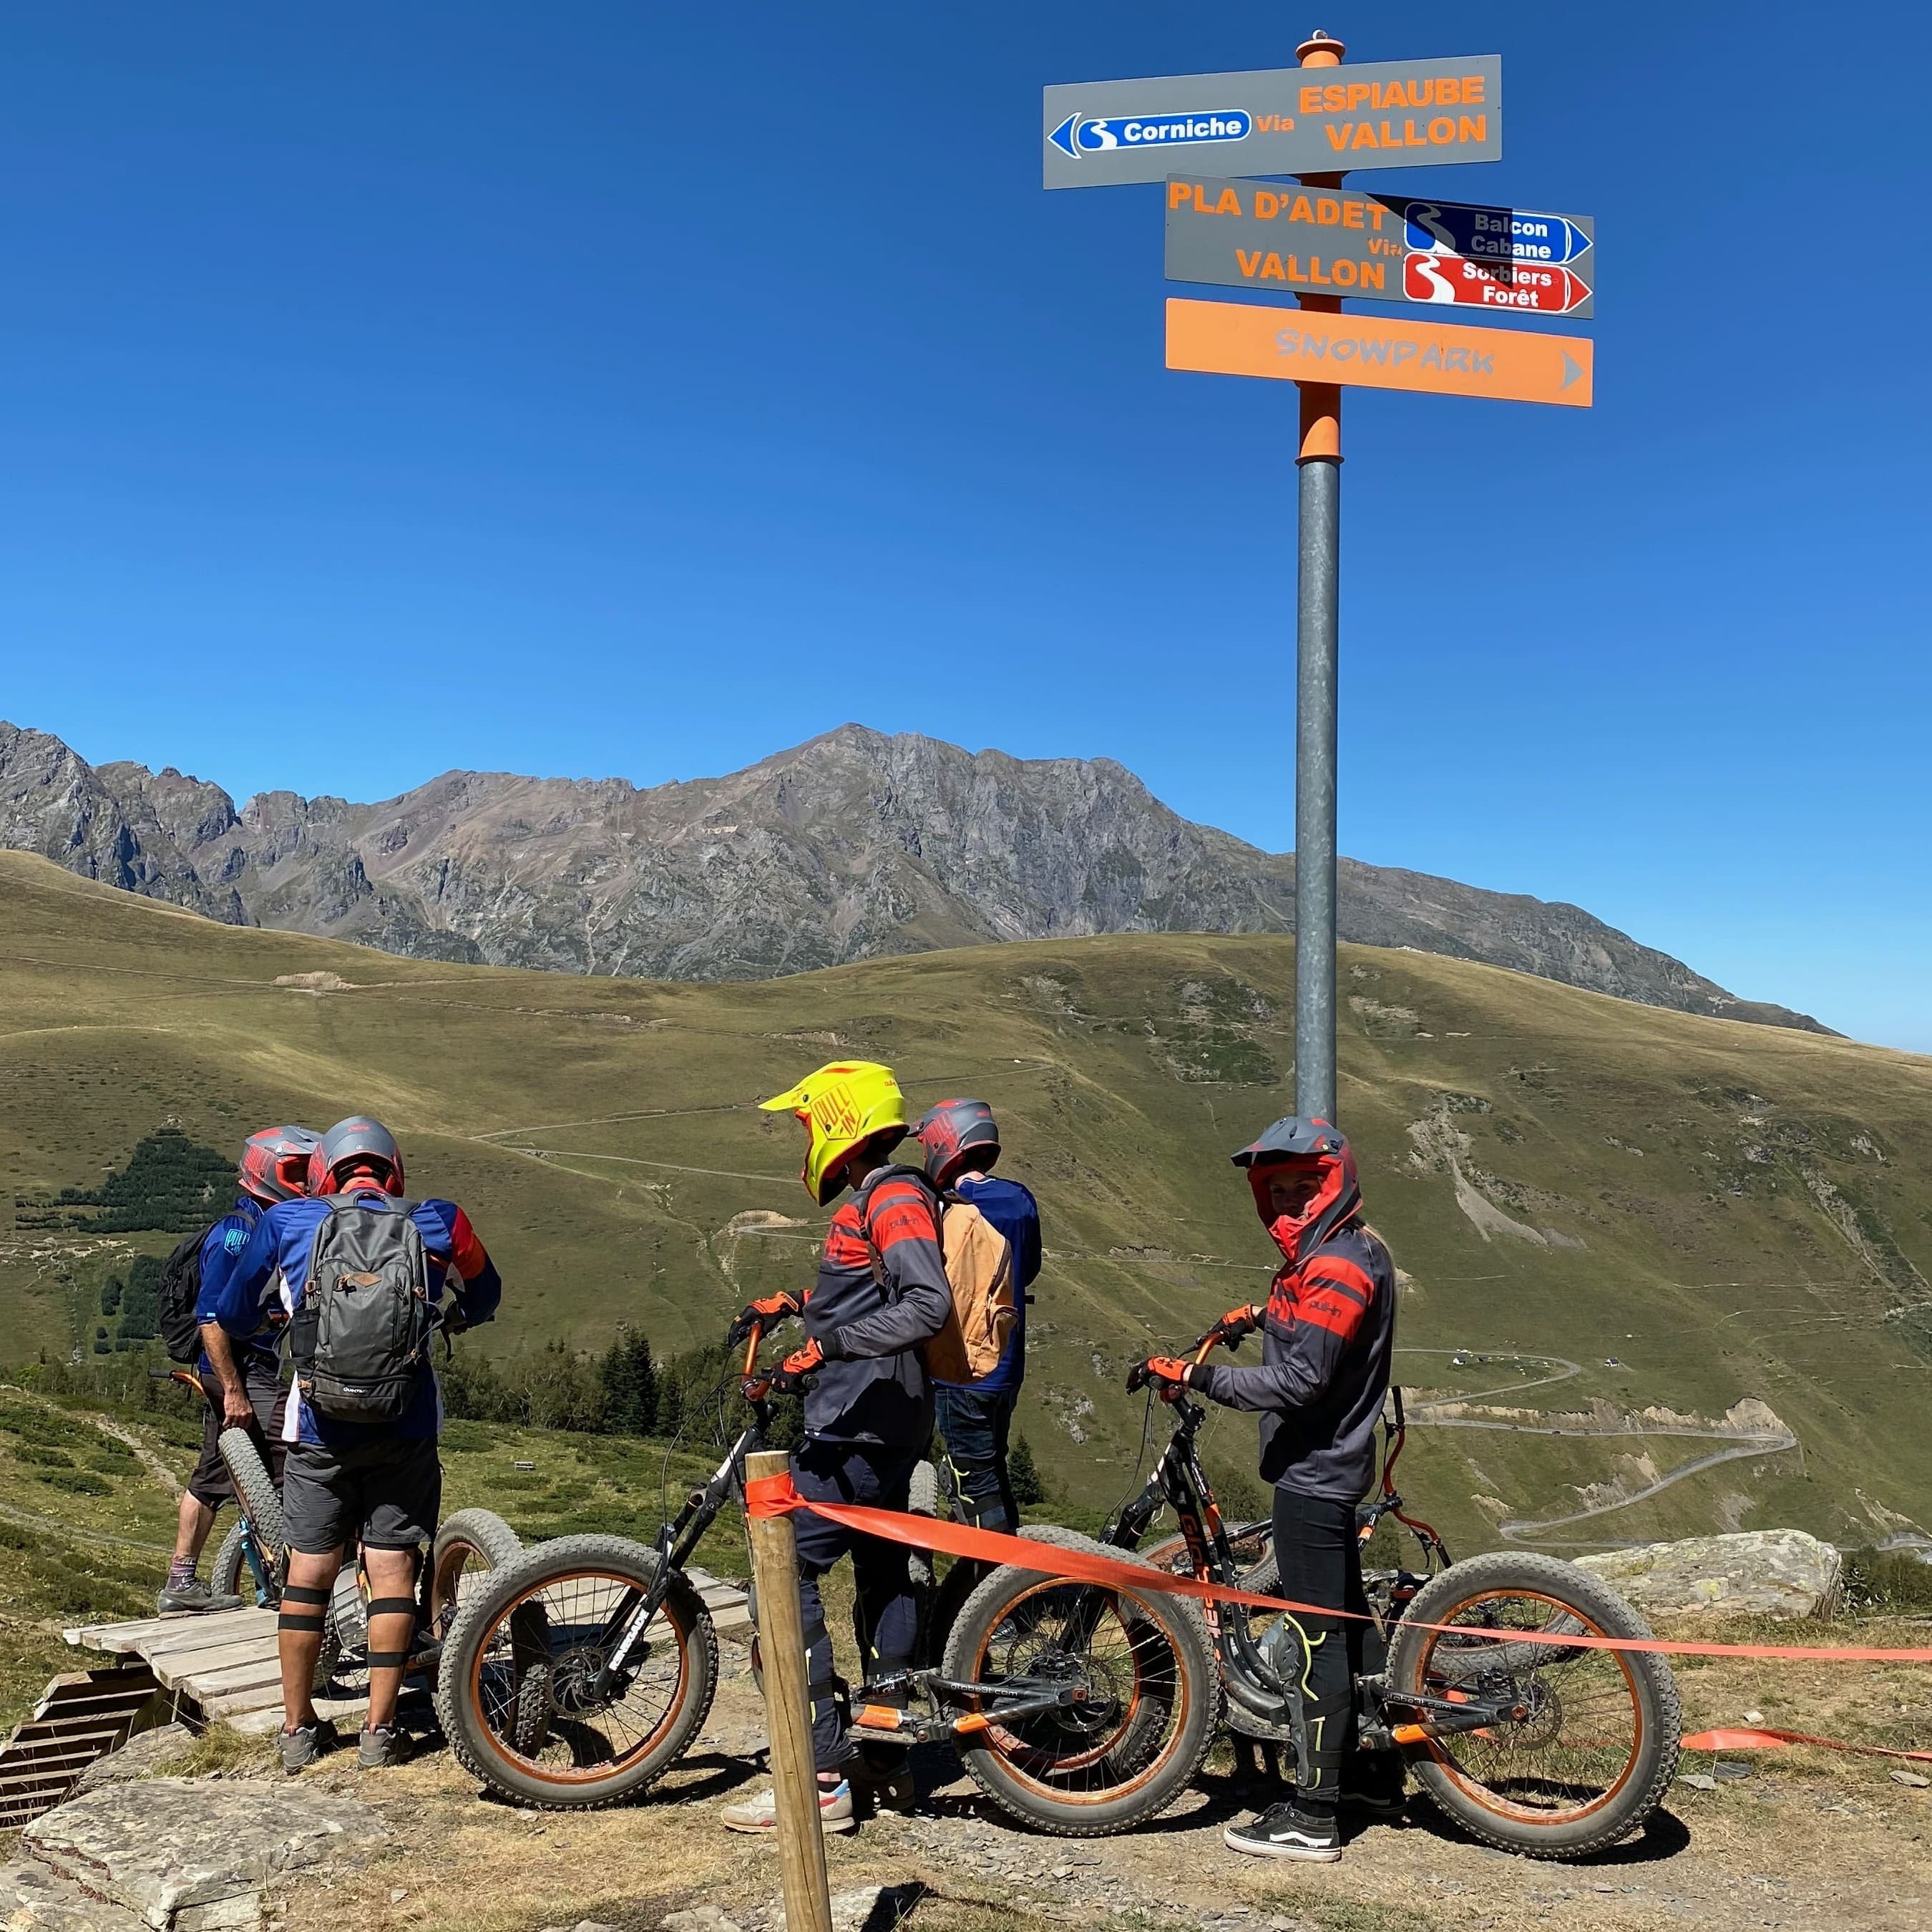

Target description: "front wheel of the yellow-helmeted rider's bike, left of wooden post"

left=436, top=1536, right=718, bottom=1810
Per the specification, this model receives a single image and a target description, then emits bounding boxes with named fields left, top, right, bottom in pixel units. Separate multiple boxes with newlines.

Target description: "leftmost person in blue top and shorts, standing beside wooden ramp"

left=157, top=1126, right=317, bottom=1614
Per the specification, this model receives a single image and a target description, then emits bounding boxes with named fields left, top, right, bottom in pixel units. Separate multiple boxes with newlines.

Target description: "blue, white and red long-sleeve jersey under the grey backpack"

left=213, top=1189, right=502, bottom=1445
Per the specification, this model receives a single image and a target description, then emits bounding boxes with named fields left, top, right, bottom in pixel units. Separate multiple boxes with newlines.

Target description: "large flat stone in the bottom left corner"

left=21, top=1777, right=389, bottom=1932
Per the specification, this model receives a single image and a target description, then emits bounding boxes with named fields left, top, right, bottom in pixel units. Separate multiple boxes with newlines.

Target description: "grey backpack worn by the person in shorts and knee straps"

left=288, top=1194, right=435, bottom=1422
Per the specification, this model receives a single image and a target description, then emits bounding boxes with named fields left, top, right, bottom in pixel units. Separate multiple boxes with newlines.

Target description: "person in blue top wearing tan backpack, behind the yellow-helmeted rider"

left=912, top=1099, right=1040, bottom=1536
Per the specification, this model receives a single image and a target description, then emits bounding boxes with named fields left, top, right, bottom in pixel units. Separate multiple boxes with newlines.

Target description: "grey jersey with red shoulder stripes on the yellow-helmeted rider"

left=806, top=1167, right=952, bottom=1449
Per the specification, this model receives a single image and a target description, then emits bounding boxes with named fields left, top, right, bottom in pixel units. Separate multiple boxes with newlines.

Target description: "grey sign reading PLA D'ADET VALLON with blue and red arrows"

left=1167, top=174, right=1596, bottom=319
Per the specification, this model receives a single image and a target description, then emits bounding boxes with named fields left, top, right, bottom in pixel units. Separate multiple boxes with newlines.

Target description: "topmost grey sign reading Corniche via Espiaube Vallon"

left=1040, top=54, right=1503, bottom=186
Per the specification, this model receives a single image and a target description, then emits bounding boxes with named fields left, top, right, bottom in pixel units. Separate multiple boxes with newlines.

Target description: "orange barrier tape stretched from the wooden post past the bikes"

left=744, top=1474, right=1932, bottom=1664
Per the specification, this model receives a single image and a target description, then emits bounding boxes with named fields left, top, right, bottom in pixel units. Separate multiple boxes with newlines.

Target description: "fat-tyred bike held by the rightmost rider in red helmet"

left=1101, top=1324, right=1683, bottom=1858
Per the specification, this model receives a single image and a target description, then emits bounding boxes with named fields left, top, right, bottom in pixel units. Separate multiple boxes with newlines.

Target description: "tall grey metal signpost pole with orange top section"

left=1294, top=33, right=1347, bottom=1121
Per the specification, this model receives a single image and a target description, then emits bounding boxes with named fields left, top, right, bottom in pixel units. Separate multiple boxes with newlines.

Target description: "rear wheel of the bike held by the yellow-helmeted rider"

left=945, top=1530, right=1221, bottom=1838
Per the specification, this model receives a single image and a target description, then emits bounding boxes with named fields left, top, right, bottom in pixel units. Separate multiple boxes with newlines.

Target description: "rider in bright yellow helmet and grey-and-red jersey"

left=721, top=1060, right=952, bottom=1832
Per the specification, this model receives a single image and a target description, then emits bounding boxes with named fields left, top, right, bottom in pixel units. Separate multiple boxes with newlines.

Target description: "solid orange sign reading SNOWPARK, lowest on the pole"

left=1167, top=296, right=1596, bottom=409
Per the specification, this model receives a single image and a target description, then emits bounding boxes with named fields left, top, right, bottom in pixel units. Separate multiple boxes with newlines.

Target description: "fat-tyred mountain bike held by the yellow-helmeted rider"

left=436, top=1330, right=1219, bottom=1835
